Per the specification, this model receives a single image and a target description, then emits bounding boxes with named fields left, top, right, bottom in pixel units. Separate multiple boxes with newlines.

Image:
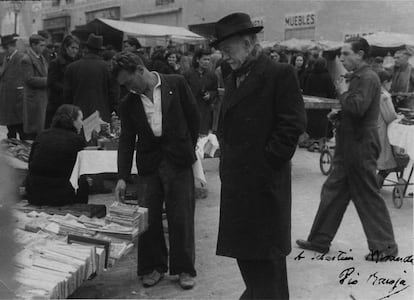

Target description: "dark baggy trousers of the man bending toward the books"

left=138, top=160, right=196, bottom=276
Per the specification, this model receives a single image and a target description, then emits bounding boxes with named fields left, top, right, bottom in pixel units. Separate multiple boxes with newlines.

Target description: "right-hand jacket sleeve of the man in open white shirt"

left=179, top=77, right=200, bottom=148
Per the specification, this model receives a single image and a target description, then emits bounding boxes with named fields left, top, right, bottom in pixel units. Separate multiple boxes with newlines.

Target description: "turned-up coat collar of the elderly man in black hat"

left=223, top=54, right=270, bottom=115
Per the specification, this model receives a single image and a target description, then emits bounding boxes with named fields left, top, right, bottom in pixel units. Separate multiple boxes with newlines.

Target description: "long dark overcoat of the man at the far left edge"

left=0, top=52, right=24, bottom=125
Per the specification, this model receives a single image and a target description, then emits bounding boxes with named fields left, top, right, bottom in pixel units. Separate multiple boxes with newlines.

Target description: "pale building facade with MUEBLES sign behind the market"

left=0, top=0, right=414, bottom=41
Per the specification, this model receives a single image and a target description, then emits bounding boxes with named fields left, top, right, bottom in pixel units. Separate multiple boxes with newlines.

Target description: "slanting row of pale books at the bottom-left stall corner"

left=15, top=240, right=100, bottom=299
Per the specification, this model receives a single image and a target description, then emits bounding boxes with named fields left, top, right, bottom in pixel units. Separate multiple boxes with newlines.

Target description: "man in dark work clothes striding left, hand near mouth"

left=296, top=37, right=398, bottom=260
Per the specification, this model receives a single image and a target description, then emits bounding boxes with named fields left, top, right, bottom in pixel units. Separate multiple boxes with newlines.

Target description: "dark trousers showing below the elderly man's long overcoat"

left=237, top=257, right=289, bottom=299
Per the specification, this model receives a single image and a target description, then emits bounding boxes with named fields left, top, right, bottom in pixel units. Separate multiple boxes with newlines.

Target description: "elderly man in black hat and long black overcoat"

left=213, top=13, right=306, bottom=299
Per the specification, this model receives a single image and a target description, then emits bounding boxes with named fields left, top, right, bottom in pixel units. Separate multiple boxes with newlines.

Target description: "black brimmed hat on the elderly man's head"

left=210, top=13, right=263, bottom=47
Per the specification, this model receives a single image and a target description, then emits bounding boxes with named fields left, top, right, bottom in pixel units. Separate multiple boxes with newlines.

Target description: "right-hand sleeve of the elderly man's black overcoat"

left=264, top=65, right=306, bottom=169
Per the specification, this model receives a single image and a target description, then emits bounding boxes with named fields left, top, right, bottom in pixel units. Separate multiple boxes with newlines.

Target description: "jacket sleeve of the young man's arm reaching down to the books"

left=118, top=99, right=136, bottom=180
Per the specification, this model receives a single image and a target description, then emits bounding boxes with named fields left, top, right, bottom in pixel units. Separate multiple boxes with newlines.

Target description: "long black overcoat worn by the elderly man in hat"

left=217, top=55, right=306, bottom=259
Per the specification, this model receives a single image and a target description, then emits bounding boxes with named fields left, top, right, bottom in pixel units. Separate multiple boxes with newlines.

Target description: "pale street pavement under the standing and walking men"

left=0, top=126, right=413, bottom=300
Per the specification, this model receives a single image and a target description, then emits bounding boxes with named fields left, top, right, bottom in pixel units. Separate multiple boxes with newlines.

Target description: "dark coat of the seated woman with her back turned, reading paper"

left=26, top=128, right=85, bottom=206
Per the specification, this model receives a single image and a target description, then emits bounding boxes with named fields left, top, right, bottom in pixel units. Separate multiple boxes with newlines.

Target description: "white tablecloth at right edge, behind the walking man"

left=388, top=119, right=414, bottom=160
